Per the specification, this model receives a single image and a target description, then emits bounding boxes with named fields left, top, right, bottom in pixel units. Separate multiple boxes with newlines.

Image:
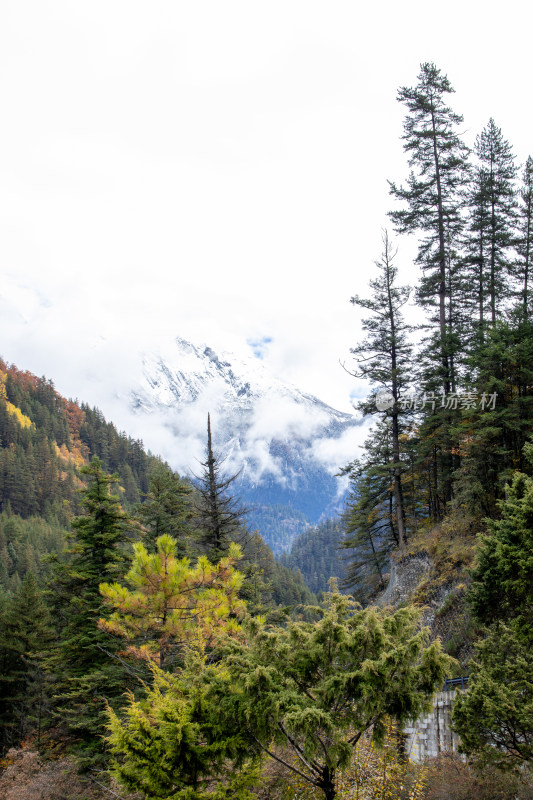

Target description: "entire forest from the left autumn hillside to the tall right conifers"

left=0, top=63, right=533, bottom=800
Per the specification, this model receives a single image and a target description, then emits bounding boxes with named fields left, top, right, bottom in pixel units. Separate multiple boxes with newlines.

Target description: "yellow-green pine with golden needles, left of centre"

left=99, top=534, right=245, bottom=669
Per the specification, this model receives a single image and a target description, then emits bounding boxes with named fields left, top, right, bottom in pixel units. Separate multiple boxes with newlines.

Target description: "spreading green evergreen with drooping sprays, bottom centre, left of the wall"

left=218, top=591, right=453, bottom=800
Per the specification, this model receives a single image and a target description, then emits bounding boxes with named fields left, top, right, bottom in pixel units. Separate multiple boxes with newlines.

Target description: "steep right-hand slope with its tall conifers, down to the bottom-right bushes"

left=334, top=63, right=533, bottom=796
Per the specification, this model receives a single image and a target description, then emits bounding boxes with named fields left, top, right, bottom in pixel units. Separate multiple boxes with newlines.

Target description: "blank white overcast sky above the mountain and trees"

left=0, top=0, right=533, bottom=438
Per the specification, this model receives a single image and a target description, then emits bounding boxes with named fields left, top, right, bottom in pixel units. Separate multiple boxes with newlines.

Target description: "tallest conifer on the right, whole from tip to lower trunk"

left=389, top=63, right=469, bottom=517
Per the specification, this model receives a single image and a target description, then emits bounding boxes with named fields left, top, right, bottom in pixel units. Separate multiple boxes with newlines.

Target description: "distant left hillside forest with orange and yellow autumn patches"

left=0, top=361, right=312, bottom=604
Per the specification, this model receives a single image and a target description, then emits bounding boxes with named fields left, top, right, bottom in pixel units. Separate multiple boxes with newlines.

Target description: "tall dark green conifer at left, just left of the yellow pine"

left=48, top=457, right=131, bottom=765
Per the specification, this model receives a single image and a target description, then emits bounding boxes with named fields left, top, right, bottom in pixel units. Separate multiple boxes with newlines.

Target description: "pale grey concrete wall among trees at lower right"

left=404, top=690, right=459, bottom=761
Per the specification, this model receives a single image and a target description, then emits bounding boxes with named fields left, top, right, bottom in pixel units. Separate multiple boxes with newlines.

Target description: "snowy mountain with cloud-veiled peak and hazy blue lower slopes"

left=130, top=338, right=361, bottom=552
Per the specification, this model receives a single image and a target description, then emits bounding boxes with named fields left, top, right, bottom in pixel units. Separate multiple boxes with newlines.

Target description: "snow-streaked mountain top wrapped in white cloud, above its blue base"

left=121, top=342, right=365, bottom=486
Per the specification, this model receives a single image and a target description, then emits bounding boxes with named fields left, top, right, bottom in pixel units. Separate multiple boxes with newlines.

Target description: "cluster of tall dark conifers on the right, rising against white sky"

left=340, top=64, right=533, bottom=608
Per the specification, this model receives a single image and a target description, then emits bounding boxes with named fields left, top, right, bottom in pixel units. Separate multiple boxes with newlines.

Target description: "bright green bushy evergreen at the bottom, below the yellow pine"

left=108, top=654, right=259, bottom=800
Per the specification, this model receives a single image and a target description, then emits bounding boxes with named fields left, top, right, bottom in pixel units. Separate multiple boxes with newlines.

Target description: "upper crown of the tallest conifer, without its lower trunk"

left=390, top=63, right=469, bottom=394
